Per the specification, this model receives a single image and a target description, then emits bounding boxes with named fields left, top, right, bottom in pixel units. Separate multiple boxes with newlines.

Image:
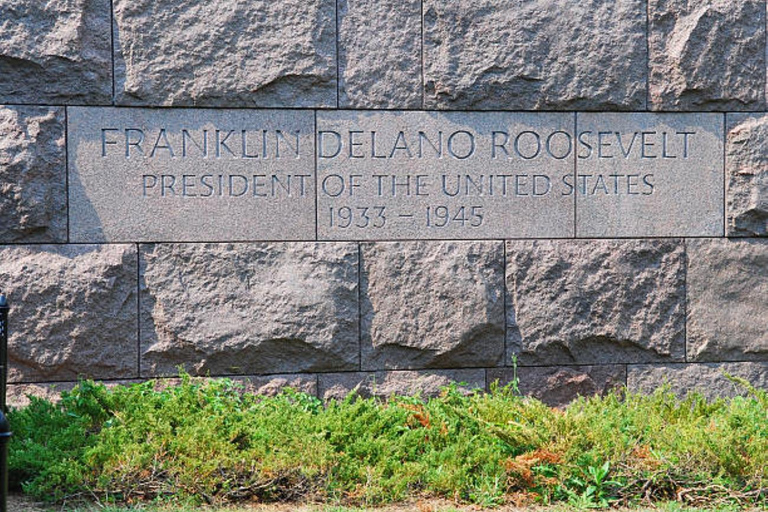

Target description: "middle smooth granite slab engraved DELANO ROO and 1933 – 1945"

left=317, top=111, right=575, bottom=240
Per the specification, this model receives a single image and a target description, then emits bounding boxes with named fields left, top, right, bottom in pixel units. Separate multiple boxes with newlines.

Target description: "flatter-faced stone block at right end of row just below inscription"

left=686, top=239, right=768, bottom=361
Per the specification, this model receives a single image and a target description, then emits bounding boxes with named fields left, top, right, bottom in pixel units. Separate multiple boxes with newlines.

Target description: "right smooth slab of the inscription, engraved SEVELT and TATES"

left=576, top=113, right=724, bottom=238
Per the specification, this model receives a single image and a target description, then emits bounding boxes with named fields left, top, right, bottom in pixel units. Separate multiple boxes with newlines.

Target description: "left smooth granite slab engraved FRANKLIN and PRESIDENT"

left=68, top=108, right=315, bottom=242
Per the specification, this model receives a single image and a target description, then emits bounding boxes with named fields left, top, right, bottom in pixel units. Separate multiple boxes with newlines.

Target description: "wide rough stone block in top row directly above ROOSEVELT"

left=424, top=0, right=647, bottom=110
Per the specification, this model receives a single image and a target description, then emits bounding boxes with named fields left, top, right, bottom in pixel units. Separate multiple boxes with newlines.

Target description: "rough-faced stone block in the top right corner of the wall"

left=648, top=0, right=766, bottom=110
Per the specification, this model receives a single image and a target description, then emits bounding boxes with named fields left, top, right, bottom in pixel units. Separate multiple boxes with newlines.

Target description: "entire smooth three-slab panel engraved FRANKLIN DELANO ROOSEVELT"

left=68, top=107, right=724, bottom=242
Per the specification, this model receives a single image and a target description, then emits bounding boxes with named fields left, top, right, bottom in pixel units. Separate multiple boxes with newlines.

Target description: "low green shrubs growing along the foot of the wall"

left=9, top=375, right=768, bottom=507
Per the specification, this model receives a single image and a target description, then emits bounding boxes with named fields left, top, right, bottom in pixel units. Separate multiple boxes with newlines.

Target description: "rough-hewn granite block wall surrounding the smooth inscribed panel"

left=0, top=0, right=768, bottom=404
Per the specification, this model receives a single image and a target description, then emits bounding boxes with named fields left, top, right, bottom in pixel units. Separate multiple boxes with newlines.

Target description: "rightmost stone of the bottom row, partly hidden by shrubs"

left=627, top=363, right=768, bottom=399
